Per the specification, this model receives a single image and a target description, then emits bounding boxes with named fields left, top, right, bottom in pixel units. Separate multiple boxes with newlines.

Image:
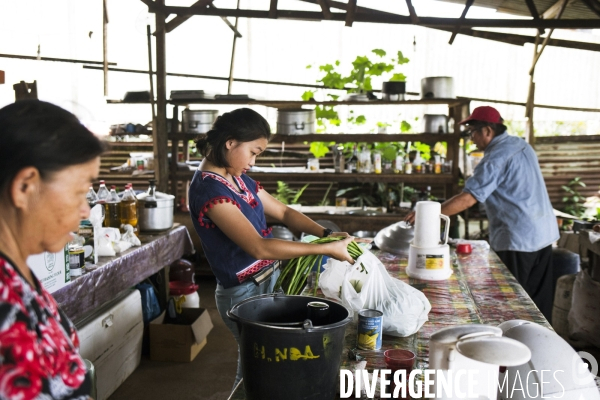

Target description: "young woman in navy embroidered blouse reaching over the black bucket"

left=189, top=108, right=353, bottom=388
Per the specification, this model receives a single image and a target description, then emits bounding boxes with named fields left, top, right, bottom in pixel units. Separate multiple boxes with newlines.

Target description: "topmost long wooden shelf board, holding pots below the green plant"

left=166, top=99, right=468, bottom=108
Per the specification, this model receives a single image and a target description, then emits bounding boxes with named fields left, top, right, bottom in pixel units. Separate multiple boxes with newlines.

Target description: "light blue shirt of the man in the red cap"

left=464, top=133, right=560, bottom=252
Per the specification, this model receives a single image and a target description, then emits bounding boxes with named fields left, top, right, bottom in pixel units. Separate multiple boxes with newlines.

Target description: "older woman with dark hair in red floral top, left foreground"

left=0, top=101, right=103, bottom=400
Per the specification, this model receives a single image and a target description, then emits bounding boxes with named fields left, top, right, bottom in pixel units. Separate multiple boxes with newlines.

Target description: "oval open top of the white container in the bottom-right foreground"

left=456, top=336, right=531, bottom=367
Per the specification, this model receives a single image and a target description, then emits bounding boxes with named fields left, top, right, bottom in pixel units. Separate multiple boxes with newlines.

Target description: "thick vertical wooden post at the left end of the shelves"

left=153, top=0, right=169, bottom=193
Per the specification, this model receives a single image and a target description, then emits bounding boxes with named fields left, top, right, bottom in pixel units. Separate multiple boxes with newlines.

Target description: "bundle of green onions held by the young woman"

left=274, top=236, right=366, bottom=296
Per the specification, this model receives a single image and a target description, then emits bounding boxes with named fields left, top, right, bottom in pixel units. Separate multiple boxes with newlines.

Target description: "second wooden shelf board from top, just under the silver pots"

left=169, top=133, right=460, bottom=143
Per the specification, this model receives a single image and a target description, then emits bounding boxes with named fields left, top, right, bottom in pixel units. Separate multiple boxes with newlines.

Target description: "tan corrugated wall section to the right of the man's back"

left=535, top=135, right=600, bottom=209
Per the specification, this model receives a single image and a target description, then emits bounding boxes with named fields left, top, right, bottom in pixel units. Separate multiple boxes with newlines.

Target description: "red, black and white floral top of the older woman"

left=0, top=254, right=91, bottom=400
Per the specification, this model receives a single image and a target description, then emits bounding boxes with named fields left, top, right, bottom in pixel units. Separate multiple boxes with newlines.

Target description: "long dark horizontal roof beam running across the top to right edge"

left=149, top=4, right=598, bottom=29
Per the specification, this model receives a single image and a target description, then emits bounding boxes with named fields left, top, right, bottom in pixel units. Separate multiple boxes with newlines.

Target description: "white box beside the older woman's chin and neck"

left=26, top=246, right=71, bottom=293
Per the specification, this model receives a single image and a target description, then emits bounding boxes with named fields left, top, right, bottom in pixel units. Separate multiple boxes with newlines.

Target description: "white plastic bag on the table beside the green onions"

left=319, top=250, right=431, bottom=336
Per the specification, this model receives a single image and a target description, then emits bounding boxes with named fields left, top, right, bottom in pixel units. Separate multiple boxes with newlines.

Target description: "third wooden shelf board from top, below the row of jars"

left=175, top=171, right=454, bottom=184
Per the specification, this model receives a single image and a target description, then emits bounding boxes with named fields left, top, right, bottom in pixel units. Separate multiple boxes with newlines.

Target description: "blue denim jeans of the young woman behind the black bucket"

left=215, top=269, right=280, bottom=391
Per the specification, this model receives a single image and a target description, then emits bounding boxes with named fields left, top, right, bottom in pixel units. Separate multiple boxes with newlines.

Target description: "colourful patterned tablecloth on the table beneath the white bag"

left=230, top=246, right=551, bottom=400
